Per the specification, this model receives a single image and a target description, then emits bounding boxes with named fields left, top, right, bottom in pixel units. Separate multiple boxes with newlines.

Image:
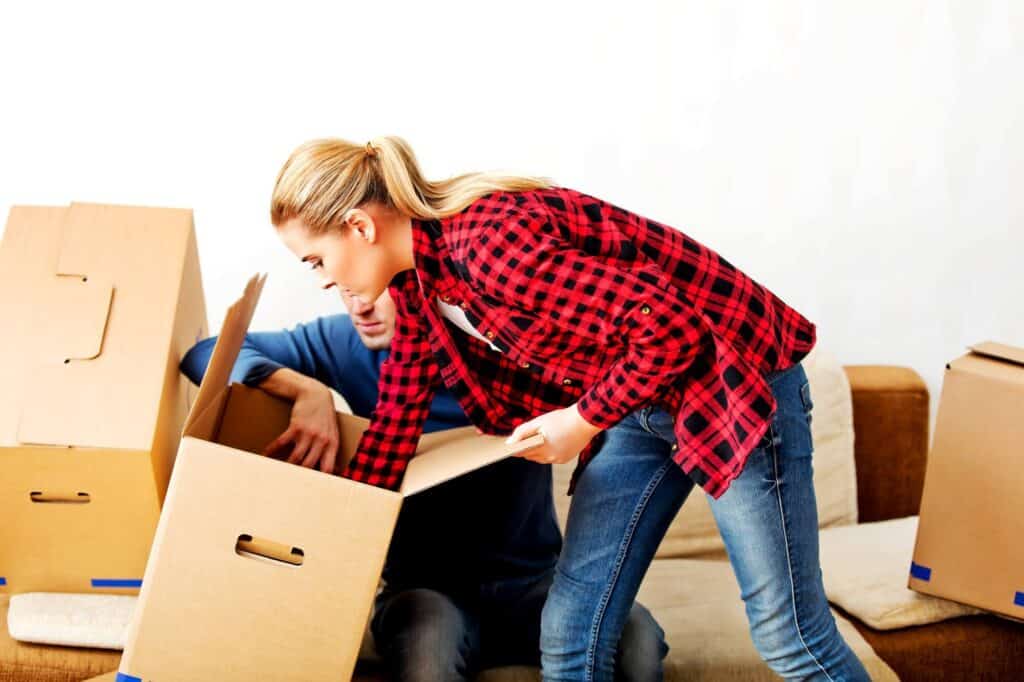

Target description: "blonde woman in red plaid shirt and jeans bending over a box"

left=270, top=137, right=867, bottom=680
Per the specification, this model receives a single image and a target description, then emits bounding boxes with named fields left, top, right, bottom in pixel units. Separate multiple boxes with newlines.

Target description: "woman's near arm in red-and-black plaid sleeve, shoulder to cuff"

left=467, top=199, right=710, bottom=430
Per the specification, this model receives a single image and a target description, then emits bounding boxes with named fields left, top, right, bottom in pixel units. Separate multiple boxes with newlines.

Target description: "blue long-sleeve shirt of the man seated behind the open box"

left=181, top=314, right=561, bottom=597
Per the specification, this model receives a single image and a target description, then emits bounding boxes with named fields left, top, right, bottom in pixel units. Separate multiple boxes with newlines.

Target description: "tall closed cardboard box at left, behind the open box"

left=0, top=204, right=206, bottom=593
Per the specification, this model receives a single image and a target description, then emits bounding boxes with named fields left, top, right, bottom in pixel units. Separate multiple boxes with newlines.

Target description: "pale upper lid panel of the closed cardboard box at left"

left=6, top=204, right=193, bottom=451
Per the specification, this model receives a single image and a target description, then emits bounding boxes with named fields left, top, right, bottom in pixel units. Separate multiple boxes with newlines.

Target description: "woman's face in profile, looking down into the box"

left=278, top=209, right=394, bottom=304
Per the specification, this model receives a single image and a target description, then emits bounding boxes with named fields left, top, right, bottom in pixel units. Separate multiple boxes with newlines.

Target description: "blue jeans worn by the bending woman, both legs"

left=541, top=358, right=868, bottom=681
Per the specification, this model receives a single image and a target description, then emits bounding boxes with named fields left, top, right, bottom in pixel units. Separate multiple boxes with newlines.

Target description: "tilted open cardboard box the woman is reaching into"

left=119, top=278, right=542, bottom=682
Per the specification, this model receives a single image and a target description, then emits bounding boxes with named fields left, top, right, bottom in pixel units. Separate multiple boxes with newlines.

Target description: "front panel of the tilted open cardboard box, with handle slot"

left=121, top=437, right=401, bottom=680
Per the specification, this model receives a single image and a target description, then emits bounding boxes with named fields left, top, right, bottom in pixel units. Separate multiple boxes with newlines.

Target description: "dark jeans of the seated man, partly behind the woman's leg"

left=371, top=572, right=669, bottom=682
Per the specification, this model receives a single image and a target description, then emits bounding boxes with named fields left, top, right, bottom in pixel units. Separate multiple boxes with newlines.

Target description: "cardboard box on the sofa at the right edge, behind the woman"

left=908, top=341, right=1024, bottom=619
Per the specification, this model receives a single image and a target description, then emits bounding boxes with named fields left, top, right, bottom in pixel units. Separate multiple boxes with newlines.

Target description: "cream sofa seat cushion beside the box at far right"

left=820, top=516, right=983, bottom=630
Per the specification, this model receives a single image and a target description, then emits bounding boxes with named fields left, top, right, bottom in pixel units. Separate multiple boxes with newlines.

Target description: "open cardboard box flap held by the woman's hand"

left=400, top=426, right=544, bottom=497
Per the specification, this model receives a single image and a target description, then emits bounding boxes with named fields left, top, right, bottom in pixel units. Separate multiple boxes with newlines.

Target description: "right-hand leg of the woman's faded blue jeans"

left=709, top=365, right=869, bottom=682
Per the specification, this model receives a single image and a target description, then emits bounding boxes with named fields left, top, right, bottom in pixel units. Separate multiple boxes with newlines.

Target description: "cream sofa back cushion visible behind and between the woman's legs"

left=554, top=348, right=857, bottom=558
